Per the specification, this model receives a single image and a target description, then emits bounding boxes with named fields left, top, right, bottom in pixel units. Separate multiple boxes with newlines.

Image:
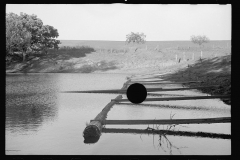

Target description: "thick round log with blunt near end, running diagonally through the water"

left=83, top=80, right=130, bottom=139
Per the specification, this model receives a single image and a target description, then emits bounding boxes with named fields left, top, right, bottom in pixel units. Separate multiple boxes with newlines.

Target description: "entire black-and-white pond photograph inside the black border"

left=5, top=3, right=232, bottom=156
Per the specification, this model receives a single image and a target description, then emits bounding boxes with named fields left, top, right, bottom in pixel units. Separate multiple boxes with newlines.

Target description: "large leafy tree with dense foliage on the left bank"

left=6, top=13, right=60, bottom=61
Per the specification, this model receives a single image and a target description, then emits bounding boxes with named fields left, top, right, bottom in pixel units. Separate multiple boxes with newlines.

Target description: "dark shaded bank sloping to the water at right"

left=159, top=55, right=231, bottom=104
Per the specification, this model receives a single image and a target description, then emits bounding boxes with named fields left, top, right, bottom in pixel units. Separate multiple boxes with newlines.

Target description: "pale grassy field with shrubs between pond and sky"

left=7, top=40, right=231, bottom=73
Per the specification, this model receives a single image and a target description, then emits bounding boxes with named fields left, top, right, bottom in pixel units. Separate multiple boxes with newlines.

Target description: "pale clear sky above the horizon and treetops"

left=6, top=3, right=232, bottom=41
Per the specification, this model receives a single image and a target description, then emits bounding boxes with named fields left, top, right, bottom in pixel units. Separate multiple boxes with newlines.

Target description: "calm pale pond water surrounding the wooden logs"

left=5, top=74, right=231, bottom=155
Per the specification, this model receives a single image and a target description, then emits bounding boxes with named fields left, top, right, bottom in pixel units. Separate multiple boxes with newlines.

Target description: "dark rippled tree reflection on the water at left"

left=5, top=74, right=58, bottom=134
